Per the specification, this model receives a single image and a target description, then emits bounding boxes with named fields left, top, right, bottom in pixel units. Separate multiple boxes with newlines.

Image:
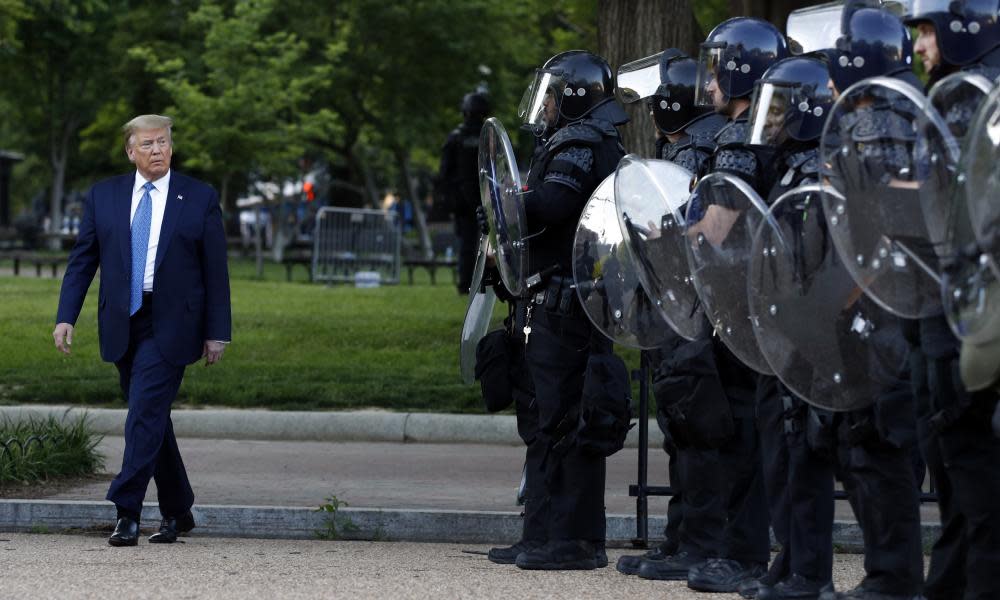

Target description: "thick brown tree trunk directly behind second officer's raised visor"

left=597, top=0, right=704, bottom=156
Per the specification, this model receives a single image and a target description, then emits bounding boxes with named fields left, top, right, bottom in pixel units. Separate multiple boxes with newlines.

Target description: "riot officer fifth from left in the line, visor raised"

left=829, top=8, right=923, bottom=599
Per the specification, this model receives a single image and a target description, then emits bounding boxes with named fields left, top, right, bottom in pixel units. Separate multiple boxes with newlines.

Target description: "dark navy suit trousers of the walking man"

left=107, top=295, right=194, bottom=517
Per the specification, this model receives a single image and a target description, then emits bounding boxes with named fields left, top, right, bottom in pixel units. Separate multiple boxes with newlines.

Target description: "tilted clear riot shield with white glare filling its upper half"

left=615, top=154, right=703, bottom=340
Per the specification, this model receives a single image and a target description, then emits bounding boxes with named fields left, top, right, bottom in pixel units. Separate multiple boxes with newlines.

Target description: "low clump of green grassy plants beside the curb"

left=0, top=417, right=104, bottom=486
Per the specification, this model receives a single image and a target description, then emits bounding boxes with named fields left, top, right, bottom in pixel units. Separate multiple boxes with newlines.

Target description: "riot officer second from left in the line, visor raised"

left=617, top=48, right=726, bottom=575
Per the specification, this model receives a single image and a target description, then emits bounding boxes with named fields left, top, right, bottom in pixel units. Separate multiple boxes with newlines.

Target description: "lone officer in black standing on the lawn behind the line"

left=439, top=92, right=490, bottom=294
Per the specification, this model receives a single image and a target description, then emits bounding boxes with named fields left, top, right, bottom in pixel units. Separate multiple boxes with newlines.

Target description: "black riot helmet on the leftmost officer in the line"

left=519, top=50, right=615, bottom=132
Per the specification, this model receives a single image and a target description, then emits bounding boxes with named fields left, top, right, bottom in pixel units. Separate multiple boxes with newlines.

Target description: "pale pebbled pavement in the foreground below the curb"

left=0, top=534, right=862, bottom=600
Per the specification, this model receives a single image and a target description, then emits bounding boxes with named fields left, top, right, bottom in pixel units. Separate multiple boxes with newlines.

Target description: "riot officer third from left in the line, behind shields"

left=639, top=17, right=788, bottom=592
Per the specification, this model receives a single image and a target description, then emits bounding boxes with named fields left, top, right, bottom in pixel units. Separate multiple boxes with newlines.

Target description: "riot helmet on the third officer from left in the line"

left=696, top=17, right=788, bottom=106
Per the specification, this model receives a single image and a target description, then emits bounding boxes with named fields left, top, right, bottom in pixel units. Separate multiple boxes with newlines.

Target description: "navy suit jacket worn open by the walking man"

left=56, top=171, right=232, bottom=366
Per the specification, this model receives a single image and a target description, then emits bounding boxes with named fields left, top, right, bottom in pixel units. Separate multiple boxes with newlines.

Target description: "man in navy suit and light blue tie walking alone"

left=52, top=115, right=231, bottom=546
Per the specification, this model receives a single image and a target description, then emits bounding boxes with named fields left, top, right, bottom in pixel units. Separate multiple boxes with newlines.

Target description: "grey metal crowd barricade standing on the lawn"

left=312, top=207, right=403, bottom=283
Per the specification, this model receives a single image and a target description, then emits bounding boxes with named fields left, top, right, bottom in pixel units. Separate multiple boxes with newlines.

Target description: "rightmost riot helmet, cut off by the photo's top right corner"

left=903, top=0, right=1000, bottom=67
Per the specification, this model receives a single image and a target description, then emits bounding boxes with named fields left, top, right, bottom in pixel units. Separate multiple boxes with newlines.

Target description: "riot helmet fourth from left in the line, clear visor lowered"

left=747, top=56, right=833, bottom=146
